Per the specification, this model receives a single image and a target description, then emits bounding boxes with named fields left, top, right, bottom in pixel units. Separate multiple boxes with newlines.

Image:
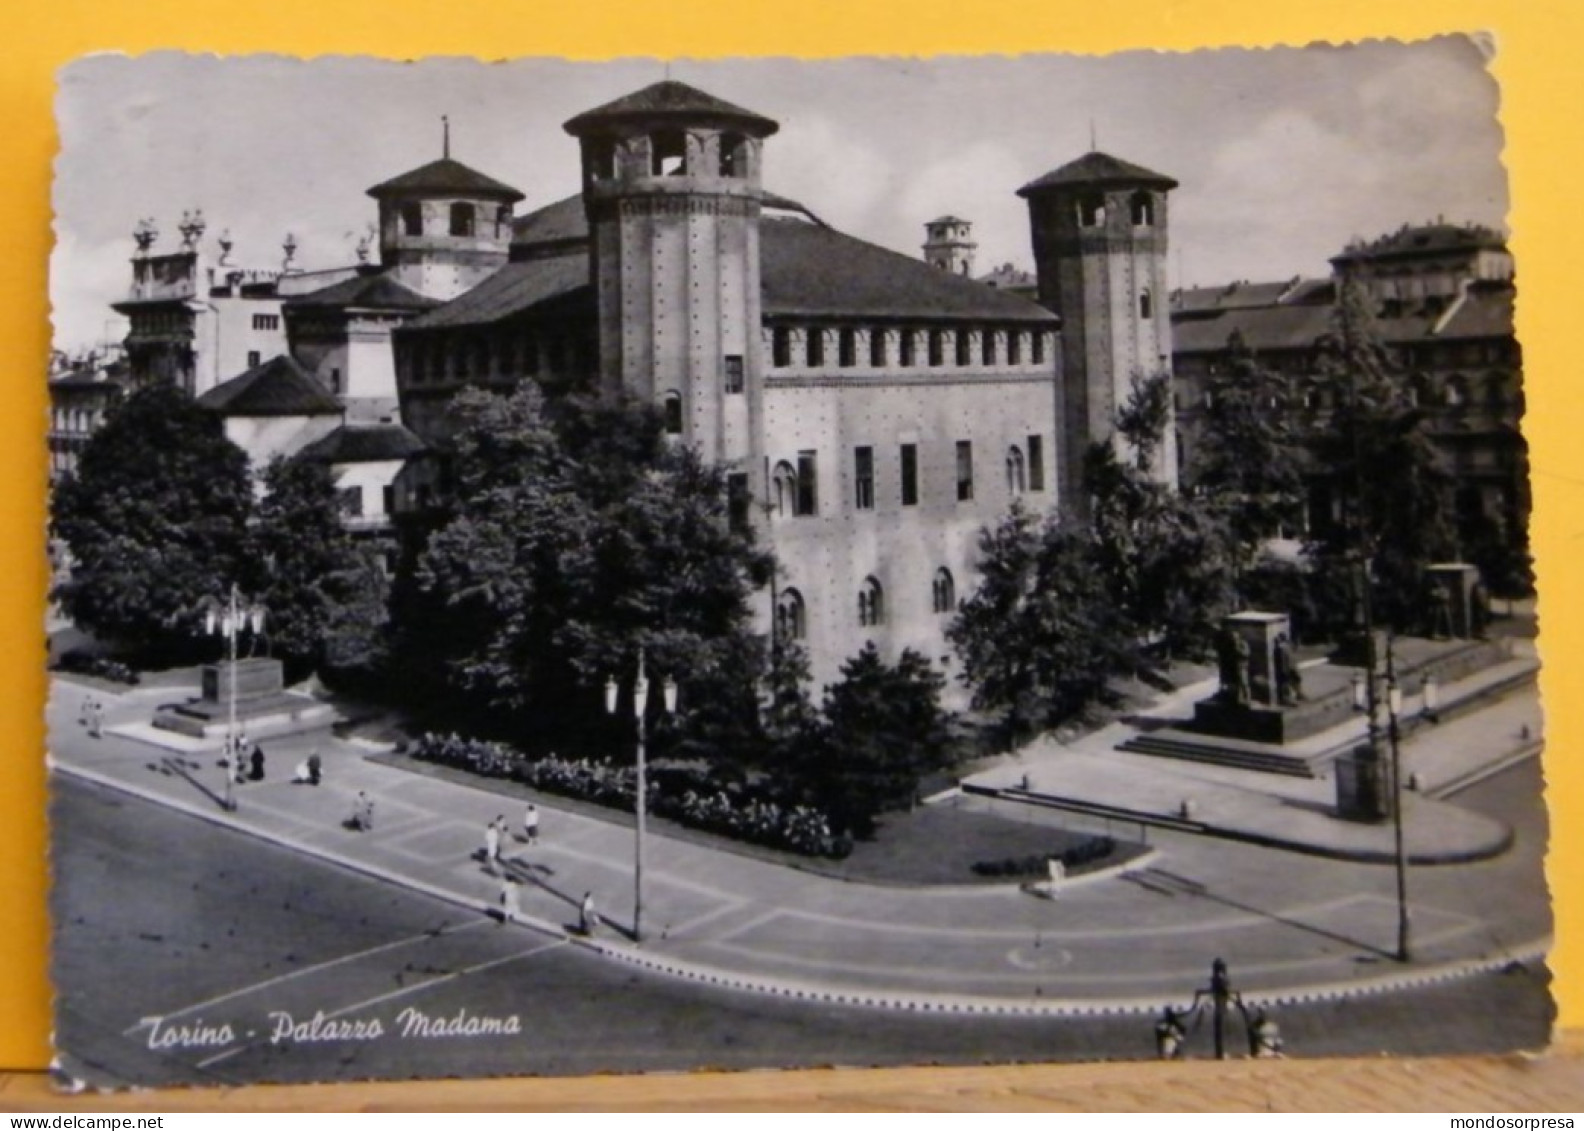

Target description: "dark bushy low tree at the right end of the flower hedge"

left=808, top=643, right=952, bottom=835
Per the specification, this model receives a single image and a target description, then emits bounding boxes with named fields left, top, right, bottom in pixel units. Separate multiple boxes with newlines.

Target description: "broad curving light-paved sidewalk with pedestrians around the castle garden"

left=48, top=668, right=1548, bottom=1014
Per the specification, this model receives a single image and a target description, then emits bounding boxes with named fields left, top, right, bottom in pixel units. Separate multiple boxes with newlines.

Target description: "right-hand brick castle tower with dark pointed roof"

left=1017, top=152, right=1177, bottom=497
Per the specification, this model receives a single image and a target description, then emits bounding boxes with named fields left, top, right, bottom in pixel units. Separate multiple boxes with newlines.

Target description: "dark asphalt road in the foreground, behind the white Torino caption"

left=52, top=770, right=1549, bottom=1083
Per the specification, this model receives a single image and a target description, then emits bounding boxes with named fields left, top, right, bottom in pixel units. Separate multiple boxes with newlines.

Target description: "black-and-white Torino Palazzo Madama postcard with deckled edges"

left=46, top=36, right=1554, bottom=1088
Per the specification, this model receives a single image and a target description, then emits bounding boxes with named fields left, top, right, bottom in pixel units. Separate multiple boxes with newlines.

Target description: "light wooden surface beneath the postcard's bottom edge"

left=0, top=1030, right=1584, bottom=1115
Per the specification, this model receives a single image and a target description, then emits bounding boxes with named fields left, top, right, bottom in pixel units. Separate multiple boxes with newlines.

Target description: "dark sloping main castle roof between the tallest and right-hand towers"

left=759, top=217, right=1057, bottom=323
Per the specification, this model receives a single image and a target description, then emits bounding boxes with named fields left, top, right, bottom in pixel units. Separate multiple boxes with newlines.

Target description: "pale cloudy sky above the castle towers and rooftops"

left=51, top=38, right=1508, bottom=347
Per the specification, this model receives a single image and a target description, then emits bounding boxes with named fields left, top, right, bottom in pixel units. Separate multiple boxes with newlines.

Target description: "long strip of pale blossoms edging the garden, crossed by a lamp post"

left=409, top=733, right=852, bottom=860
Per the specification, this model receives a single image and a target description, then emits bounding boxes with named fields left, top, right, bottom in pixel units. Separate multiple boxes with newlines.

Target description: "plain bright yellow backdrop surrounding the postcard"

left=0, top=0, right=1584, bottom=1069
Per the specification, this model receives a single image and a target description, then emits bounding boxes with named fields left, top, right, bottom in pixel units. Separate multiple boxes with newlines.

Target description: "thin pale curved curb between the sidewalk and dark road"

left=58, top=756, right=1552, bottom=1017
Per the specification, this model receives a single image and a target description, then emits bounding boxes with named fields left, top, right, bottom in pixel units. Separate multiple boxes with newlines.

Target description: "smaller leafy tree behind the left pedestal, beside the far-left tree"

left=250, top=458, right=386, bottom=670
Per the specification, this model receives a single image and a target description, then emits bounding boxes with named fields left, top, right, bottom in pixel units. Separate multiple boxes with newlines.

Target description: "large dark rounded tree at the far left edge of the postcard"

left=52, top=383, right=253, bottom=653
